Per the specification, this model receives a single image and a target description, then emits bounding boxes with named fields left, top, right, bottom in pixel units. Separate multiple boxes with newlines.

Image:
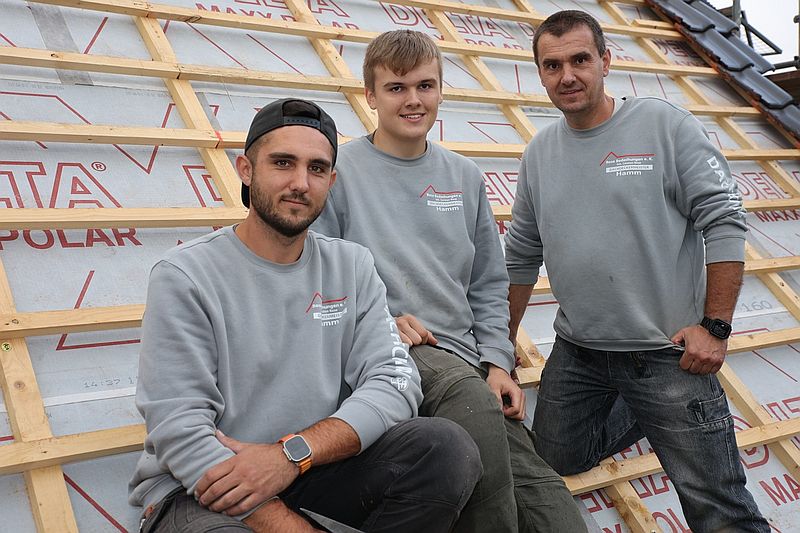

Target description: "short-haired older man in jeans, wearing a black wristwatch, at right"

left=506, top=11, right=770, bottom=532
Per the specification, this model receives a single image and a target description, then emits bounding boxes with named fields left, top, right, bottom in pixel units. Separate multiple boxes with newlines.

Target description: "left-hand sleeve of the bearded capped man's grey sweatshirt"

left=136, top=261, right=233, bottom=490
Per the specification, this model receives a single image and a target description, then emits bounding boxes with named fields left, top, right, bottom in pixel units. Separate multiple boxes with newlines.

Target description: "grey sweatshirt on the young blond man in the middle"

left=312, top=137, right=514, bottom=371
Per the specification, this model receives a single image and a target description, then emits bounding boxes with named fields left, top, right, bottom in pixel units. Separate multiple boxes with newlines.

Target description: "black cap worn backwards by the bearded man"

left=242, top=98, right=339, bottom=207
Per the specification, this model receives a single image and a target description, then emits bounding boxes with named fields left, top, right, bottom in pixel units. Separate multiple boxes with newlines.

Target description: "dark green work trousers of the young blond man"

left=411, top=345, right=586, bottom=533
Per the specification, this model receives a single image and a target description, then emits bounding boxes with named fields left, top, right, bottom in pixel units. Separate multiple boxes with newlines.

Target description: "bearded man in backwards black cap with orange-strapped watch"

left=130, top=100, right=481, bottom=532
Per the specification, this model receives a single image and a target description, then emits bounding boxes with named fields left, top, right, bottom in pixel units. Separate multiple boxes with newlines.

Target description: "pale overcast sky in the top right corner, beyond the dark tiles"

left=711, top=0, right=800, bottom=69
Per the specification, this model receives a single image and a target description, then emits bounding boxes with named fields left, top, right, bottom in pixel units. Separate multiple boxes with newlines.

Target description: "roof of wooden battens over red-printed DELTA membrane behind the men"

left=0, top=0, right=800, bottom=533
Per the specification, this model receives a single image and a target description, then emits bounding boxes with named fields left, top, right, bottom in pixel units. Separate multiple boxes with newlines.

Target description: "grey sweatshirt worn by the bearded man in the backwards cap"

left=129, top=227, right=422, bottom=506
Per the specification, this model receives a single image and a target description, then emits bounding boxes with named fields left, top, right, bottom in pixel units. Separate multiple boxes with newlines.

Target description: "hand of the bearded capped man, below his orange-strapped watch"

left=195, top=431, right=300, bottom=516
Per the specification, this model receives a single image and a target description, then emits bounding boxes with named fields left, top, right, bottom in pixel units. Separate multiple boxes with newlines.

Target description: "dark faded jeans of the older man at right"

left=533, top=337, right=770, bottom=533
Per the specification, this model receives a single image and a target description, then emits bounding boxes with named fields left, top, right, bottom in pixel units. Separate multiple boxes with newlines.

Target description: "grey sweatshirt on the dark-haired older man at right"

left=506, top=98, right=747, bottom=351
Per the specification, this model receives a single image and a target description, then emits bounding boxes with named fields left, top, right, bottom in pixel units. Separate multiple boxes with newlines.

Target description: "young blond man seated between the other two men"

left=315, top=30, right=585, bottom=533
